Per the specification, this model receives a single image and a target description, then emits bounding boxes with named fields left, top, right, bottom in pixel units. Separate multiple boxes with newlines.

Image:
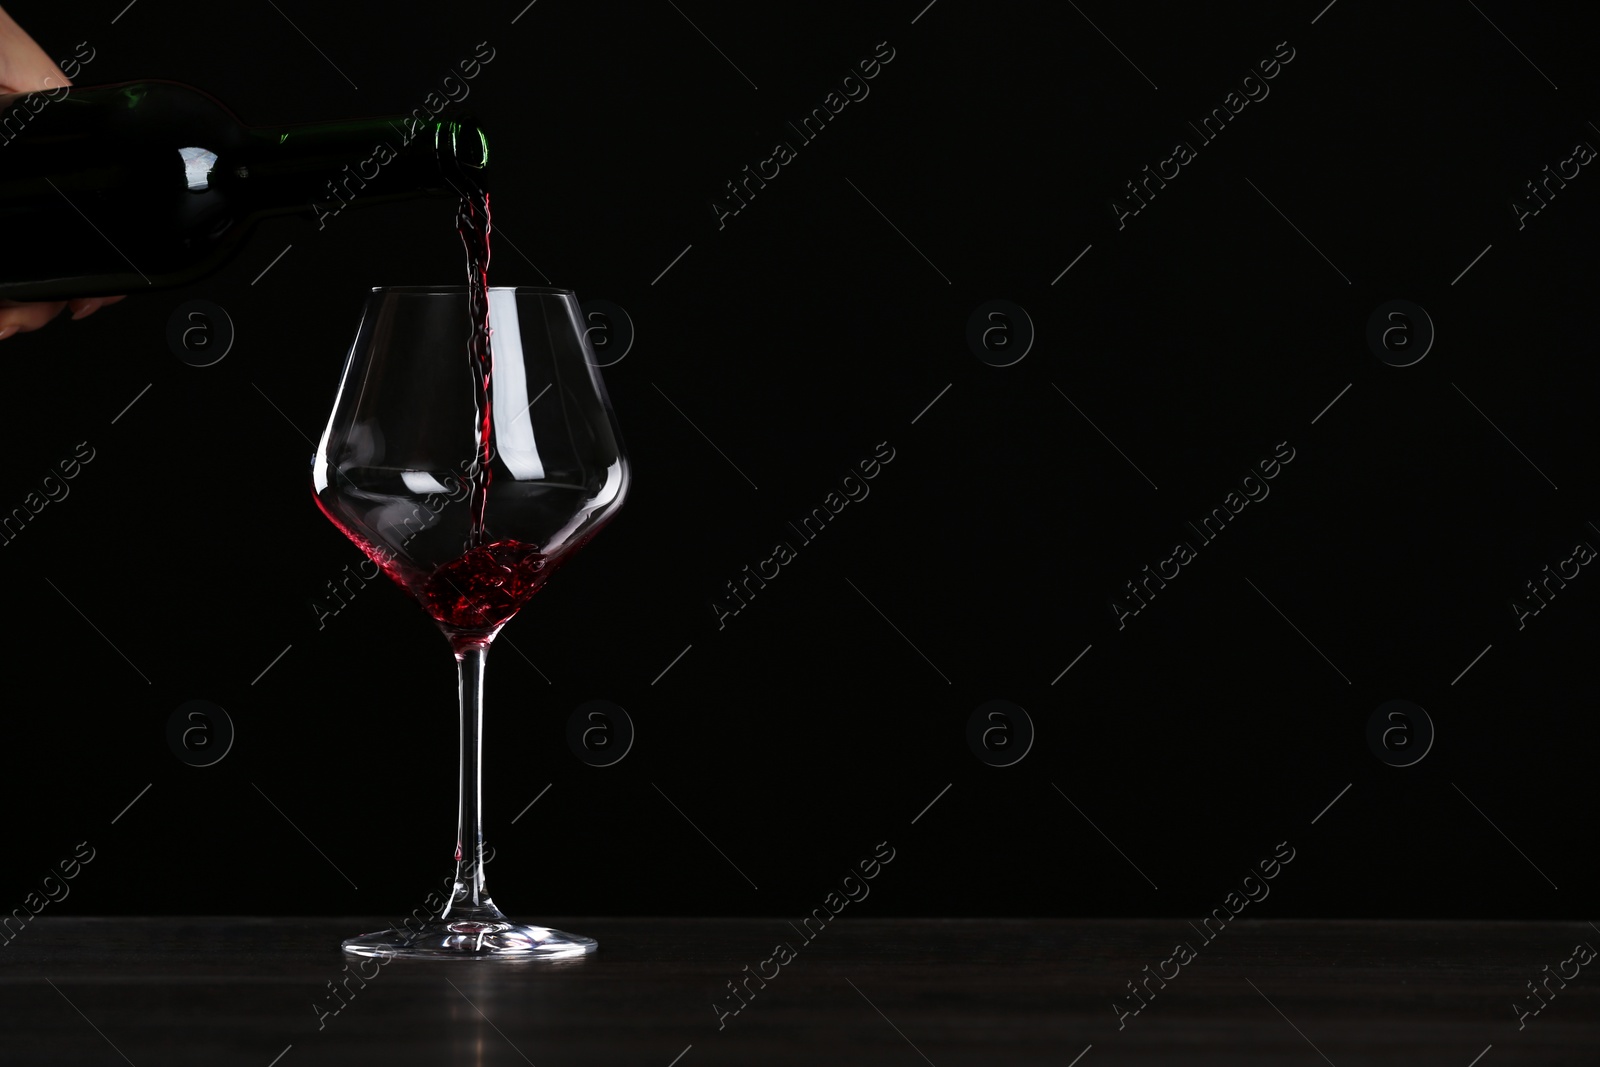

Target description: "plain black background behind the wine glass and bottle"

left=0, top=0, right=1600, bottom=920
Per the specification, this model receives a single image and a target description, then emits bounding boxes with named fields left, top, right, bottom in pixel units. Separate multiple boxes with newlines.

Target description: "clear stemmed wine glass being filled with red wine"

left=312, top=286, right=629, bottom=958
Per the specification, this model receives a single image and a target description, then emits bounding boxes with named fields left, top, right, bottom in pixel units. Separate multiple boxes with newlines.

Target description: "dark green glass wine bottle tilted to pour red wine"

left=0, top=80, right=488, bottom=301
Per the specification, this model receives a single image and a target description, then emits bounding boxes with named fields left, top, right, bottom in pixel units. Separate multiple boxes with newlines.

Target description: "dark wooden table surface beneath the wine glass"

left=0, top=917, right=1600, bottom=1067
